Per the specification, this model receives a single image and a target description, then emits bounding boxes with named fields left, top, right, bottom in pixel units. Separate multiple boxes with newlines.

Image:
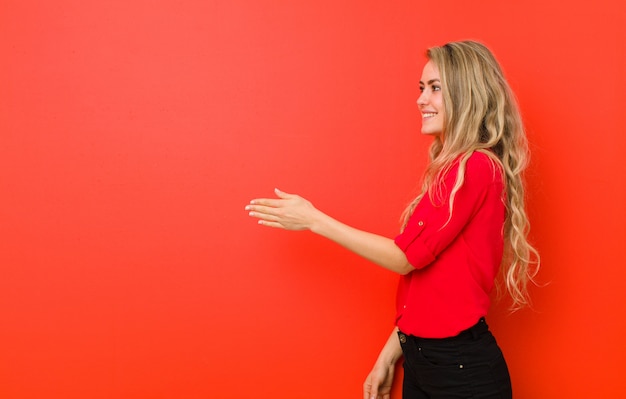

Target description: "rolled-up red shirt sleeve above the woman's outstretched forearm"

left=394, top=153, right=502, bottom=269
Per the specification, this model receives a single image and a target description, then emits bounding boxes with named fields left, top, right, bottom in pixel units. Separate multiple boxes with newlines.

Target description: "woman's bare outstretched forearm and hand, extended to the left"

left=246, top=189, right=414, bottom=274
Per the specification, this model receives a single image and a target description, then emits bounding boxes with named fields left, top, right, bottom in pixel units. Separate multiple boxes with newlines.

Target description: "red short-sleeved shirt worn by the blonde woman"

left=395, top=152, right=505, bottom=338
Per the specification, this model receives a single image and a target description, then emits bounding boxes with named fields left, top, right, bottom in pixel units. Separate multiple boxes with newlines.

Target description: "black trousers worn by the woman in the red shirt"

left=398, top=318, right=512, bottom=399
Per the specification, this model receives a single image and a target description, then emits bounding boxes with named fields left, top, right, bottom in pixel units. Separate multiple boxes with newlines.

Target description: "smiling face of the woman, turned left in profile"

left=417, top=61, right=446, bottom=136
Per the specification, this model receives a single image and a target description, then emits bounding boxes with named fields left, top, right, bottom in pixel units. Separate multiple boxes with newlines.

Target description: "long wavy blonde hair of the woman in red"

left=403, top=41, right=539, bottom=310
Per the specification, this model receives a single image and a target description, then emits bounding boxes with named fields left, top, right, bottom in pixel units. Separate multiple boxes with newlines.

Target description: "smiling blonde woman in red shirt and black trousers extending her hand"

left=246, top=41, right=538, bottom=399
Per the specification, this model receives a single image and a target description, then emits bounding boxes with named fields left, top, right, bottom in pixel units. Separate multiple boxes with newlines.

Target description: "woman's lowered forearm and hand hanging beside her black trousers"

left=363, top=328, right=402, bottom=399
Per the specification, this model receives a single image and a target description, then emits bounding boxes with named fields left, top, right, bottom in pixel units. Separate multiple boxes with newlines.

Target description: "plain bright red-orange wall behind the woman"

left=0, top=0, right=626, bottom=399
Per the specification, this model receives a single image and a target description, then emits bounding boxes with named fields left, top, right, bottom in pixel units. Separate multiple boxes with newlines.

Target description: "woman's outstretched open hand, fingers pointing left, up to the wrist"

left=246, top=189, right=320, bottom=230
